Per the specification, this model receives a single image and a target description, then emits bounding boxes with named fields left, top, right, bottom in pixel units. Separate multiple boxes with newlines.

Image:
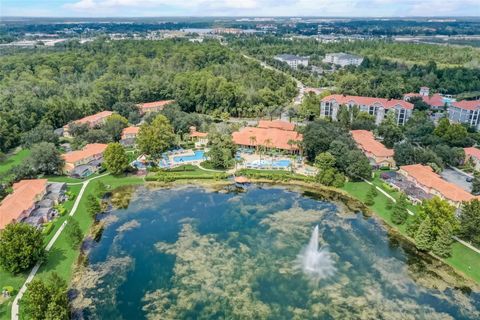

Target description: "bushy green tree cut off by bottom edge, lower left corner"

left=20, top=273, right=70, bottom=320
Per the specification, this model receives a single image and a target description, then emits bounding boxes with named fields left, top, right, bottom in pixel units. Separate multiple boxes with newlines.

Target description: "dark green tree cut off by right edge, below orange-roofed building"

left=458, top=199, right=480, bottom=246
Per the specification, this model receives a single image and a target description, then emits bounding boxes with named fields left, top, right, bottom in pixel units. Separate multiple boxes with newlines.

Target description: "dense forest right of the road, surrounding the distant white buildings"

left=231, top=37, right=480, bottom=98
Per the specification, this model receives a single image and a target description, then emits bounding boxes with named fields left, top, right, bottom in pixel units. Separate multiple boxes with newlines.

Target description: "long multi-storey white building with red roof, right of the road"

left=320, top=94, right=413, bottom=125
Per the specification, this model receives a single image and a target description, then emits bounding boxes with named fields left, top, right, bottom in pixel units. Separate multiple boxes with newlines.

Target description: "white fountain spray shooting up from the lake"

left=297, top=225, right=336, bottom=281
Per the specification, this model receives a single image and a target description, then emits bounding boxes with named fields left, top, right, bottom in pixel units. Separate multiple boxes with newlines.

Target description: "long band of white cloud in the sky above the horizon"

left=57, top=0, right=480, bottom=16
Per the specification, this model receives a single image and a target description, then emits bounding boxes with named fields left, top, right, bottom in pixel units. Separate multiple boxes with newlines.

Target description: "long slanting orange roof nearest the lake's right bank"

left=400, top=164, right=475, bottom=202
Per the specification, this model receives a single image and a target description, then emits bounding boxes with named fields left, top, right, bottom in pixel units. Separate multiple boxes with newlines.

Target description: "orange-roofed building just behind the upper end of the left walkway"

left=62, top=143, right=107, bottom=178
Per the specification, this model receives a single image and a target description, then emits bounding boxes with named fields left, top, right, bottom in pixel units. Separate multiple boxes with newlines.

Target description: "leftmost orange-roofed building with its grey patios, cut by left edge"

left=0, top=179, right=66, bottom=230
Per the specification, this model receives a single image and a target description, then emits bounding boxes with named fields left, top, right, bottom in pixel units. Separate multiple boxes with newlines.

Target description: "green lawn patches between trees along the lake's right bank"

left=342, top=179, right=480, bottom=283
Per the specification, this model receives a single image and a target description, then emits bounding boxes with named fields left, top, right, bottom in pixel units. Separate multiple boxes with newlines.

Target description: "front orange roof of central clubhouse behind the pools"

left=232, top=127, right=303, bottom=150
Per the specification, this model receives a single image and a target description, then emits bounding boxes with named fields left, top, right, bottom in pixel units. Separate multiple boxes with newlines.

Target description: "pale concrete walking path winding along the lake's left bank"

left=11, top=173, right=109, bottom=320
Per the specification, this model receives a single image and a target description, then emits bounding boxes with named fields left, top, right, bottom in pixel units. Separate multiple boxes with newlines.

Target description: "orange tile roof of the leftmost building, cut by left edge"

left=0, top=179, right=47, bottom=230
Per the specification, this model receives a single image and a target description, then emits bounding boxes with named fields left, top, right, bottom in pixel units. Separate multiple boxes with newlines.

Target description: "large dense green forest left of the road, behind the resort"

left=0, top=40, right=297, bottom=151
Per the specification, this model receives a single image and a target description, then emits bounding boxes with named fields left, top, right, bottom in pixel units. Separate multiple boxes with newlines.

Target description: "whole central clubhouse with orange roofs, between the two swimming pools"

left=232, top=120, right=303, bottom=153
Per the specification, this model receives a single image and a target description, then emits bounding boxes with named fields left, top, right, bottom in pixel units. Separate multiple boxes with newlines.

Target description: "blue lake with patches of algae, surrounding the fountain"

left=74, top=186, right=480, bottom=320
